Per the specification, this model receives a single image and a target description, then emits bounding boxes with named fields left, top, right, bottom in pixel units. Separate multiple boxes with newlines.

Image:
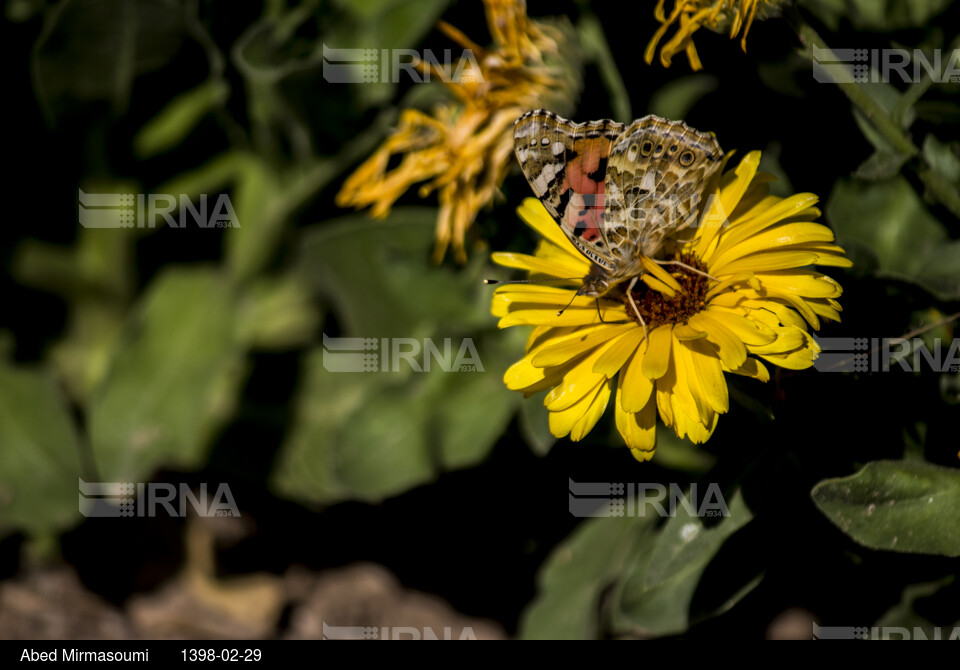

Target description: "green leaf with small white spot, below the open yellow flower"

left=614, top=491, right=758, bottom=637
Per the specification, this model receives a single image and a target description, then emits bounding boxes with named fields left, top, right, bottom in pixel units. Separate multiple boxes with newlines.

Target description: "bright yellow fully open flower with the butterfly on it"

left=492, top=152, right=851, bottom=460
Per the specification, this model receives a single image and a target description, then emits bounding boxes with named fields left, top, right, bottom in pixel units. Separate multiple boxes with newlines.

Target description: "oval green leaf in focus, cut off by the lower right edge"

left=811, top=461, right=960, bottom=556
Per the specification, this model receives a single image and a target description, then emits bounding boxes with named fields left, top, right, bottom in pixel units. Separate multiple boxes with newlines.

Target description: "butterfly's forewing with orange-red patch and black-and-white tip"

left=514, top=109, right=626, bottom=271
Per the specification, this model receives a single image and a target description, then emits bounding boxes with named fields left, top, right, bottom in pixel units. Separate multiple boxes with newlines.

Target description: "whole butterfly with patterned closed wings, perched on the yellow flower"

left=513, top=109, right=723, bottom=330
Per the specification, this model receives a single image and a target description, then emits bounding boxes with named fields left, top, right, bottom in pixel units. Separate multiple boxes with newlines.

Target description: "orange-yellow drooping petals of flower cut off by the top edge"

left=644, top=0, right=785, bottom=70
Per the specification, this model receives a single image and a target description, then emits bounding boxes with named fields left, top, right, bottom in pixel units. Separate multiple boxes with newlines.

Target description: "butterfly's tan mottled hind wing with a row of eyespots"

left=603, top=115, right=723, bottom=272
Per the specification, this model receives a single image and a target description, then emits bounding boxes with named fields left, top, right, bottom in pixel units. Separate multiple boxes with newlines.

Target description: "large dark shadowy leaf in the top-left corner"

left=33, top=0, right=184, bottom=118
